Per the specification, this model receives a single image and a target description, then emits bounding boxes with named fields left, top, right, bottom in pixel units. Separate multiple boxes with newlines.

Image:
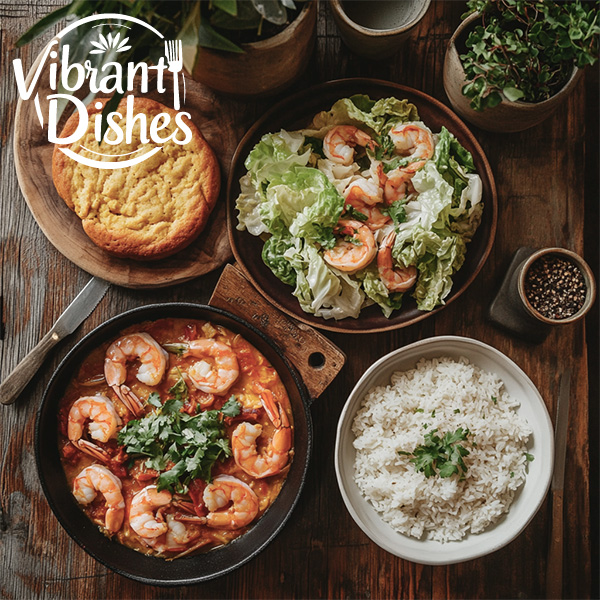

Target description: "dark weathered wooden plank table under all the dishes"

left=0, top=0, right=598, bottom=598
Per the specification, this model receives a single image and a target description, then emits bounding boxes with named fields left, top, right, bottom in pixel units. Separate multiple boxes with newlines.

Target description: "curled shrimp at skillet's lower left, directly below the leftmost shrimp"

left=73, top=465, right=125, bottom=533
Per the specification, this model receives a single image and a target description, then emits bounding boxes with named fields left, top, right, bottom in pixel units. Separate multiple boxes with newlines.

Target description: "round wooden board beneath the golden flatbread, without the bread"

left=14, top=40, right=234, bottom=288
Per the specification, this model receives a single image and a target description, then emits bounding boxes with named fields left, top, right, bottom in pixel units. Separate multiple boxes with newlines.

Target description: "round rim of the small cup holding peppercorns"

left=517, top=248, right=596, bottom=325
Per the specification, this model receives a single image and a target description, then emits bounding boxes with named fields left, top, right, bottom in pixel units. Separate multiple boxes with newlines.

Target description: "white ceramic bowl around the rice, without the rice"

left=335, top=336, right=554, bottom=565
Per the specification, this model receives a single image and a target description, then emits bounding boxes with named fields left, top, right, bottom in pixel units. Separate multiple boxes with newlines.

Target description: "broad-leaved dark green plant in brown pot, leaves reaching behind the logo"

left=17, top=0, right=318, bottom=96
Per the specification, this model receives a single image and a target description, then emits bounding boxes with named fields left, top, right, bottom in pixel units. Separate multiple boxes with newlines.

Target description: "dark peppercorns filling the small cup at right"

left=525, top=255, right=587, bottom=320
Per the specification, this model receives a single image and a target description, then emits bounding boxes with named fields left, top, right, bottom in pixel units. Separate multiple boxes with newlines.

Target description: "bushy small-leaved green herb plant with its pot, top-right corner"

left=444, top=0, right=600, bottom=132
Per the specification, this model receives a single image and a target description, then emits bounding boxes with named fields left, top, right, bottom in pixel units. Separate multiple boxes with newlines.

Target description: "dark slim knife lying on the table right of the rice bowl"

left=546, top=370, right=571, bottom=598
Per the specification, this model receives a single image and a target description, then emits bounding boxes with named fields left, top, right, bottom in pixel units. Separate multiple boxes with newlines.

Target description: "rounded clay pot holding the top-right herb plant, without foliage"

left=444, top=13, right=582, bottom=133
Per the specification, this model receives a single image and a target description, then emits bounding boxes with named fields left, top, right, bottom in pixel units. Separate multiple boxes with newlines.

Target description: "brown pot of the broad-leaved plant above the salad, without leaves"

left=192, top=0, right=318, bottom=97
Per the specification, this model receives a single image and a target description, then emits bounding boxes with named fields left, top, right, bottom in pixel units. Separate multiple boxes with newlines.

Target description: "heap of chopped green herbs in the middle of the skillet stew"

left=118, top=378, right=241, bottom=493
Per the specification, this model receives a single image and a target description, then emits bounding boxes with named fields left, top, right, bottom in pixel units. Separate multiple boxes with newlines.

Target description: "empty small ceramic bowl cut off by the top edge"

left=330, top=0, right=431, bottom=60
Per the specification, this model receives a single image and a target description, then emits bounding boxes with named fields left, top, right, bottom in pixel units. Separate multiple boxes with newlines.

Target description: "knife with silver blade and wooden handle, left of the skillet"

left=0, top=277, right=110, bottom=404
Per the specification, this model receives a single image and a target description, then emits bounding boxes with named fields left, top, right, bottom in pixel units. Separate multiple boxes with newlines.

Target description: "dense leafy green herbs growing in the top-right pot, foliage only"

left=460, top=0, right=600, bottom=111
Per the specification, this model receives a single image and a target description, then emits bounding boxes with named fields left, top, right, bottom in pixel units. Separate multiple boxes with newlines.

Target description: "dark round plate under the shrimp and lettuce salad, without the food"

left=227, top=79, right=498, bottom=333
